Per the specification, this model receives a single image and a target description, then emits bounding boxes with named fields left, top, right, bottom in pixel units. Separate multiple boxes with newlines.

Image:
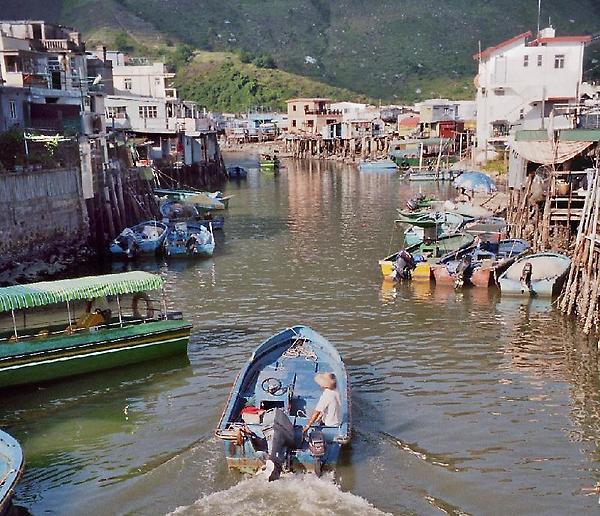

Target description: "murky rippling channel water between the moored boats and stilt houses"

left=0, top=156, right=600, bottom=515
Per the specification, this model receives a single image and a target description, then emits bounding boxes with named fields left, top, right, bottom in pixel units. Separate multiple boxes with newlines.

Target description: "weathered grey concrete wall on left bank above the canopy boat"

left=0, top=169, right=87, bottom=263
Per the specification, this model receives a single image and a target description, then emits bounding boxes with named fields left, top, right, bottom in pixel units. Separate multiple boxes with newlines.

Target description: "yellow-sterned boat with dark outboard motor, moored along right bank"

left=379, top=233, right=474, bottom=279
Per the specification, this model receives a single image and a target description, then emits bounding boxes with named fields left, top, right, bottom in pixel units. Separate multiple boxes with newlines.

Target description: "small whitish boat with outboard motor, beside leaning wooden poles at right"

left=498, top=253, right=571, bottom=296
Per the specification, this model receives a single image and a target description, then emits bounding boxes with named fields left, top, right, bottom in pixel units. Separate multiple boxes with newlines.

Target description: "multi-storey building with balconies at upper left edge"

left=0, top=20, right=105, bottom=135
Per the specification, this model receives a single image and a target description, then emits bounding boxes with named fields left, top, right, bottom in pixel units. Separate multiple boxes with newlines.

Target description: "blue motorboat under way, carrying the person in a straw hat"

left=215, top=326, right=351, bottom=475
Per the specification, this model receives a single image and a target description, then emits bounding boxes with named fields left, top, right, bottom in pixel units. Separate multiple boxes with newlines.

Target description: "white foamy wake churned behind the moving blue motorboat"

left=170, top=473, right=386, bottom=516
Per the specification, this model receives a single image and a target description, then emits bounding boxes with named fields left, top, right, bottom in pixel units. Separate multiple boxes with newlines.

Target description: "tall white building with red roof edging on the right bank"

left=473, top=27, right=591, bottom=161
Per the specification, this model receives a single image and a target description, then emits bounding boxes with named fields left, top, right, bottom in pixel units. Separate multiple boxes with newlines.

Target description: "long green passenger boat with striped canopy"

left=0, top=271, right=192, bottom=388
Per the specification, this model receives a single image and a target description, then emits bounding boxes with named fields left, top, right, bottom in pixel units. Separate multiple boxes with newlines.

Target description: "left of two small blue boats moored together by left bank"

left=109, top=220, right=168, bottom=258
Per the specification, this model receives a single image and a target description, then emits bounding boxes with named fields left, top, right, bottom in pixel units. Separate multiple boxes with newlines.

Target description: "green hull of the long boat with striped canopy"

left=0, top=320, right=191, bottom=388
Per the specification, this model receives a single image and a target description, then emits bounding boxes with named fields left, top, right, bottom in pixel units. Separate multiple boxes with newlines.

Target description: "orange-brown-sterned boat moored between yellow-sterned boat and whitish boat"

left=433, top=238, right=530, bottom=288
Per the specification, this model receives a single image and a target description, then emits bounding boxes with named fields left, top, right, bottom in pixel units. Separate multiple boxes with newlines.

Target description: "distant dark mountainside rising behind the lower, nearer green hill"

left=3, top=0, right=600, bottom=101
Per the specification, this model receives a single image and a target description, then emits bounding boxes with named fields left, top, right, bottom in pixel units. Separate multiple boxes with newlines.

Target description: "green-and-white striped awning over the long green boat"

left=0, top=271, right=163, bottom=312
